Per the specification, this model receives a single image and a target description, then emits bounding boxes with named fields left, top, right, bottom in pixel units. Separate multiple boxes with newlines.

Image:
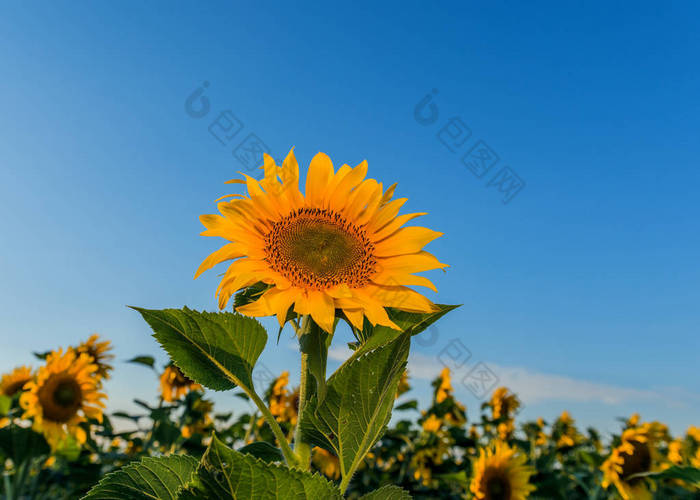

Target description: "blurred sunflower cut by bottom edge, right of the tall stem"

left=469, top=441, right=535, bottom=500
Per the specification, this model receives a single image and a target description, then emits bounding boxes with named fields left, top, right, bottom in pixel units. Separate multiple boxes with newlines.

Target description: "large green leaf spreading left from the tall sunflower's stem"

left=134, top=307, right=267, bottom=391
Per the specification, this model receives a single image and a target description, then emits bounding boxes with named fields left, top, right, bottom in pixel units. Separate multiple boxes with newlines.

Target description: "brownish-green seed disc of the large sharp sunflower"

left=266, top=209, right=376, bottom=289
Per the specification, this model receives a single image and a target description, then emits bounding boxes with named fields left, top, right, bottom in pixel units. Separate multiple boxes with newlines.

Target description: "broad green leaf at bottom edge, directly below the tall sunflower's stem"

left=180, top=435, right=342, bottom=500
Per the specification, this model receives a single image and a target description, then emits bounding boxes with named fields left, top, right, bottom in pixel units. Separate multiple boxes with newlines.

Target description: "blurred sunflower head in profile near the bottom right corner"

left=601, top=423, right=661, bottom=500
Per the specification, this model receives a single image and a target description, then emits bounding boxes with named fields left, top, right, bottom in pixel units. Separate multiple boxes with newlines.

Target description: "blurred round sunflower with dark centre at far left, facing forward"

left=20, top=349, right=105, bottom=448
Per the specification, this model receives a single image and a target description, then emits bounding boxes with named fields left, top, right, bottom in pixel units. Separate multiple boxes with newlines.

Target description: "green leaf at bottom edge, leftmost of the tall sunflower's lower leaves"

left=83, top=455, right=197, bottom=500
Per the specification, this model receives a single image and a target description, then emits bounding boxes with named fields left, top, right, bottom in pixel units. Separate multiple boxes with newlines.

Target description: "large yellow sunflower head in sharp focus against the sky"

left=195, top=151, right=447, bottom=332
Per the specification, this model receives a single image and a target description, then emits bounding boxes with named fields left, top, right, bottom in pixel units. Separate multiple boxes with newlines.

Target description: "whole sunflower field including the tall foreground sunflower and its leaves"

left=0, top=152, right=700, bottom=500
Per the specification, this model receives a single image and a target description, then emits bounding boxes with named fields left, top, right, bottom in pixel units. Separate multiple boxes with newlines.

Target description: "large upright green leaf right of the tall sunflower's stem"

left=301, top=334, right=410, bottom=486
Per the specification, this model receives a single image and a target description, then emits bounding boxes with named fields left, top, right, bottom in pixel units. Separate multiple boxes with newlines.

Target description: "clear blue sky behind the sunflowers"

left=0, top=2, right=700, bottom=432
